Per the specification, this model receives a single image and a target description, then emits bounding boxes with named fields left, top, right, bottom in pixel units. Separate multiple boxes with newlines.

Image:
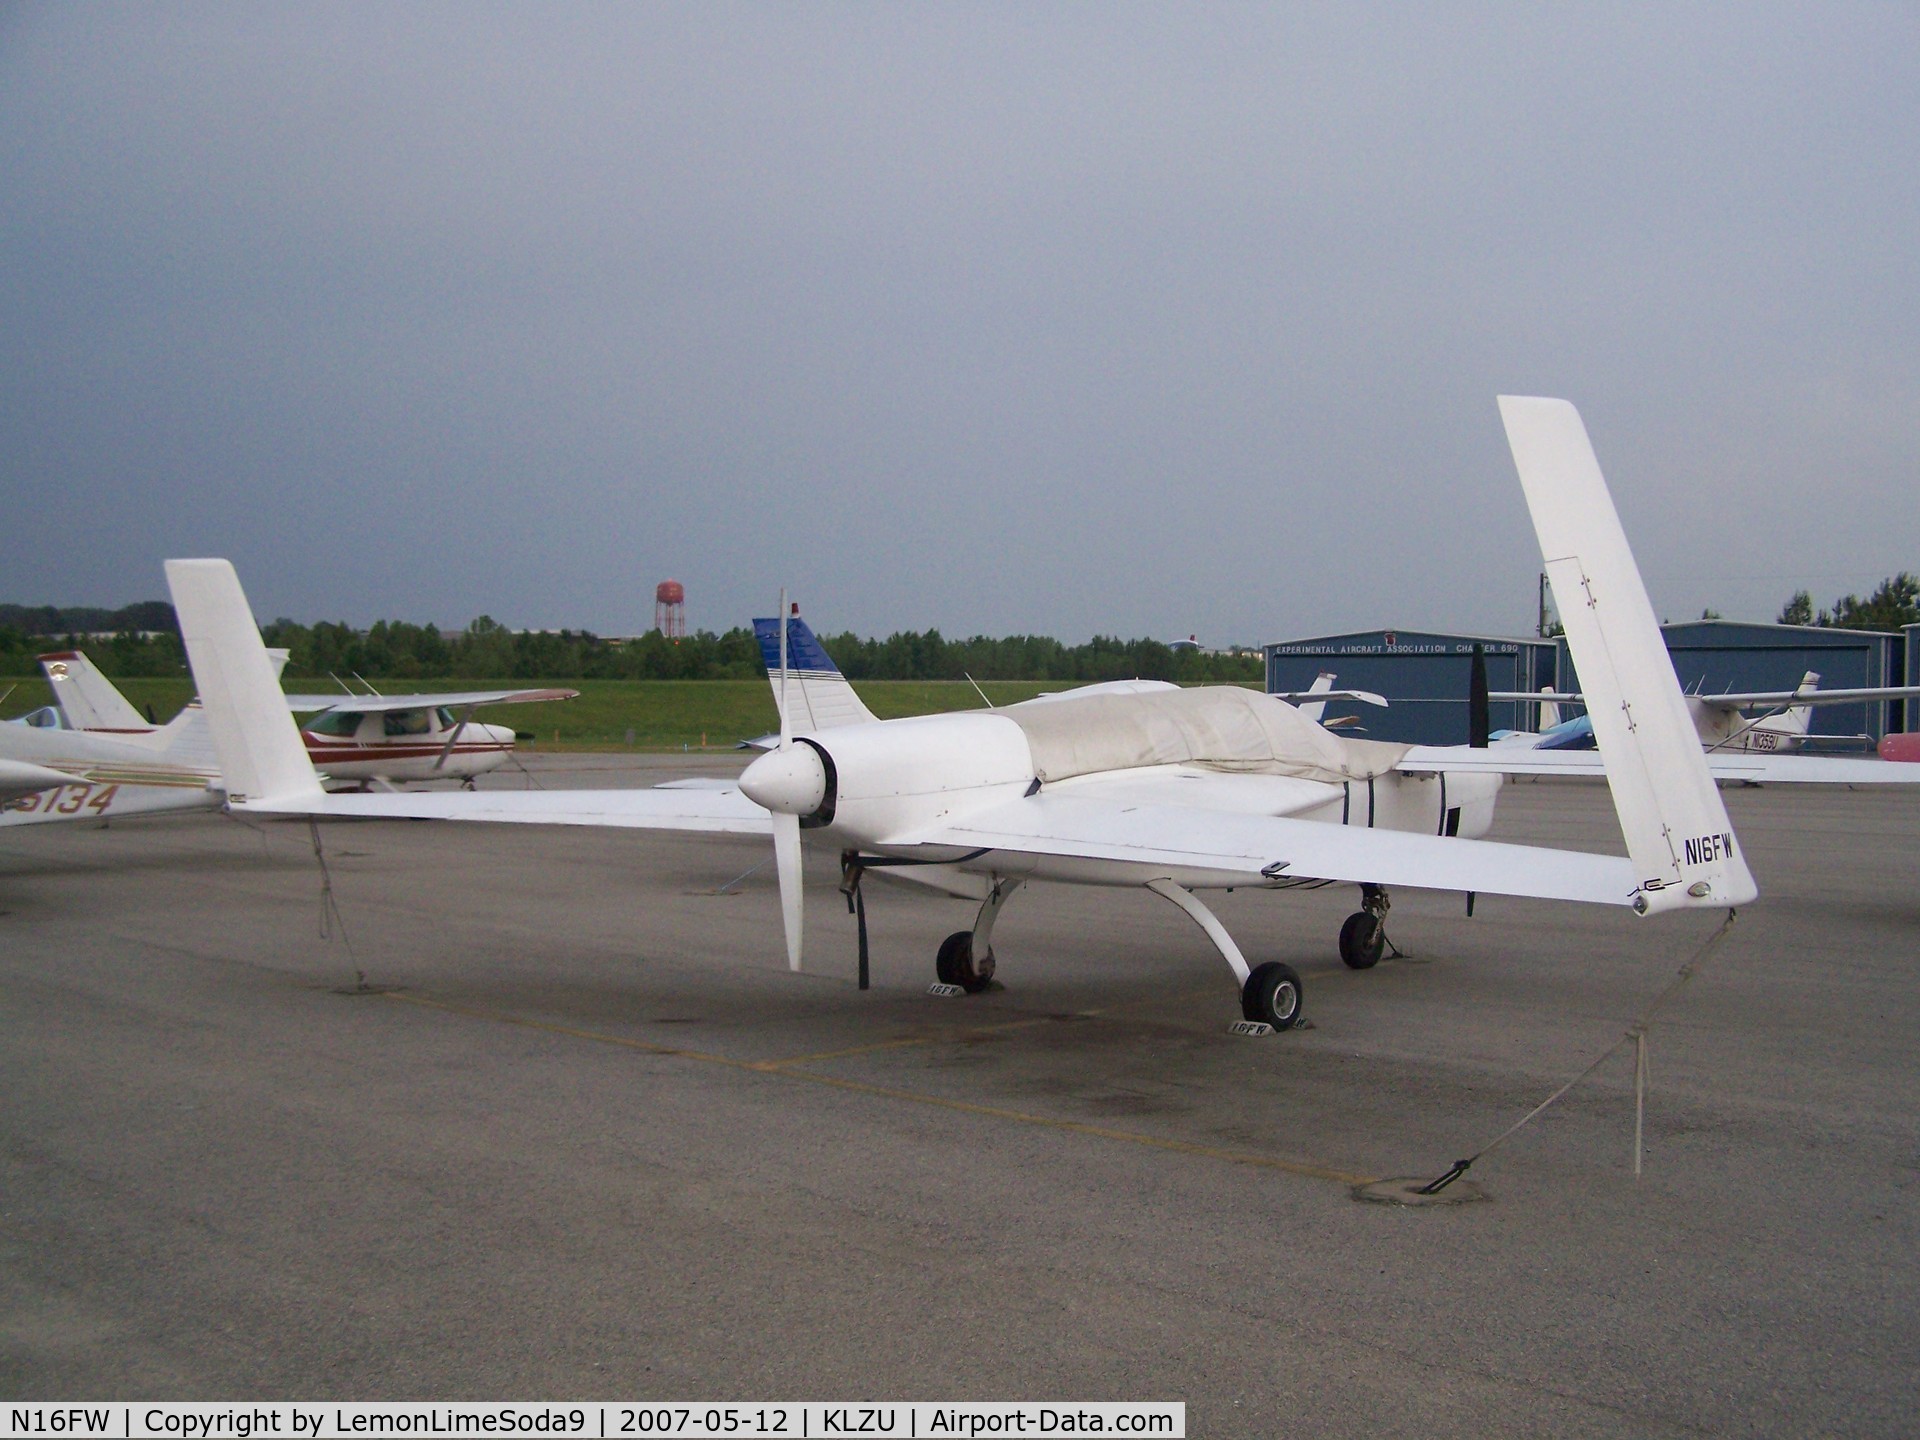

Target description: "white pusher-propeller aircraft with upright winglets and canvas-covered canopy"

left=167, top=397, right=1757, bottom=1029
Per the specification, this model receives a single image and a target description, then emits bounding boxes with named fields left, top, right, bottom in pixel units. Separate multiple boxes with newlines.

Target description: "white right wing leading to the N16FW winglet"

left=881, top=793, right=1636, bottom=904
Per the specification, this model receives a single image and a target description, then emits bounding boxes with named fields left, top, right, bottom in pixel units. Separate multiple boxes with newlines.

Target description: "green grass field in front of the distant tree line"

left=0, top=678, right=1259, bottom=751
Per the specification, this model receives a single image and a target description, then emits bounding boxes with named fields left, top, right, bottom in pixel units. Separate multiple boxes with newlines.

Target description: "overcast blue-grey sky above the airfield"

left=0, top=2, right=1920, bottom=643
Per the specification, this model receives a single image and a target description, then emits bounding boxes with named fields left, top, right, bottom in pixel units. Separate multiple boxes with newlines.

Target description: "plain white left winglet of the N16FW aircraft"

left=167, top=561, right=321, bottom=804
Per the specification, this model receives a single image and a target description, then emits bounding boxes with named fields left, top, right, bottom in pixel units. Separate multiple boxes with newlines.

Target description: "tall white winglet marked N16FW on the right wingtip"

left=1500, top=396, right=1759, bottom=914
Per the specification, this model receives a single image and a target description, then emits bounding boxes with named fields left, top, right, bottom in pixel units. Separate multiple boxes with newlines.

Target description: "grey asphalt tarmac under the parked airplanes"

left=0, top=756, right=1920, bottom=1436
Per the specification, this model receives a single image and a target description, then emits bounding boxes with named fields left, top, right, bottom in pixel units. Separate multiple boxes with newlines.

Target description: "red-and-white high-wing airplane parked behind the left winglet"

left=40, top=651, right=580, bottom=789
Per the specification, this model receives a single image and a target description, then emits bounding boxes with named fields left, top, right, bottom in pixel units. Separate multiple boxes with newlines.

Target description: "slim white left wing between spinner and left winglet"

left=246, top=783, right=774, bottom=835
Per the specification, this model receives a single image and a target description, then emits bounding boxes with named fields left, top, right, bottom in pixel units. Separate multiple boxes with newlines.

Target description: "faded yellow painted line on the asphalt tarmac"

left=382, top=991, right=1380, bottom=1187
